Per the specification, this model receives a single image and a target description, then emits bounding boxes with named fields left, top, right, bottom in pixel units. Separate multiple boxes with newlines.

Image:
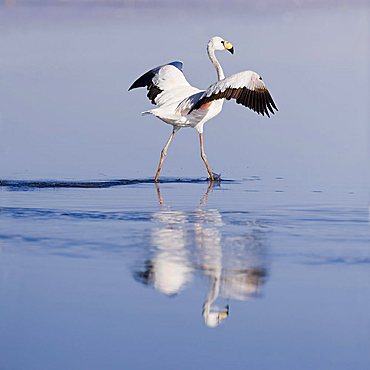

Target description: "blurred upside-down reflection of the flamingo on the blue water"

left=133, top=185, right=267, bottom=328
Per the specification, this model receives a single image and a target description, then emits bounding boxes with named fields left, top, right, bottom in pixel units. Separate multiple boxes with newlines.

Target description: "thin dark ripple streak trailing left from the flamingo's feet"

left=0, top=178, right=235, bottom=190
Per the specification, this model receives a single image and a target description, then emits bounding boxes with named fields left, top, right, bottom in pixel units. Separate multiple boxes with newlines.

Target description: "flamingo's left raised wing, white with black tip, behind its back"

left=128, top=61, right=190, bottom=105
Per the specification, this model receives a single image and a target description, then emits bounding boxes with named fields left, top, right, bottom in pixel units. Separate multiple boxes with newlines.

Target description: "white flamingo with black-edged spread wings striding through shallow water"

left=129, top=36, right=278, bottom=182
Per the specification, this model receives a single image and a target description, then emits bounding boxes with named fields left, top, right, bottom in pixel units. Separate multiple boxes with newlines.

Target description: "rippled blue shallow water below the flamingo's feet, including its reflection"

left=0, top=179, right=370, bottom=369
